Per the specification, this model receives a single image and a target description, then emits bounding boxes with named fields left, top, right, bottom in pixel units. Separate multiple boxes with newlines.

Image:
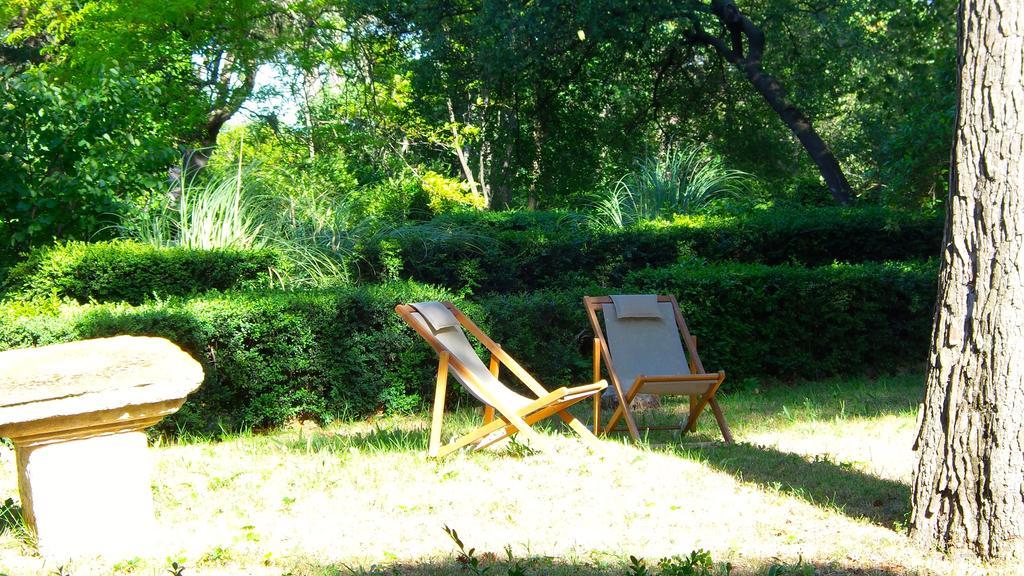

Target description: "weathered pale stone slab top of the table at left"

left=0, top=336, right=203, bottom=436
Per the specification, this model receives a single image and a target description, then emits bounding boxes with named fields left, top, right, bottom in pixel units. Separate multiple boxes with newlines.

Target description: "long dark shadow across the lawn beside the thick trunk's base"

left=676, top=444, right=910, bottom=529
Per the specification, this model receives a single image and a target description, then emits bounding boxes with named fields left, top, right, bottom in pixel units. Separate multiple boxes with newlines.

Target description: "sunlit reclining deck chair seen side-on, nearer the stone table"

left=394, top=302, right=608, bottom=457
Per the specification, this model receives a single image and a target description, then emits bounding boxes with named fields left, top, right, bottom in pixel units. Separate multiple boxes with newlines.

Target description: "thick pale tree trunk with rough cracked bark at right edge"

left=910, top=0, right=1024, bottom=562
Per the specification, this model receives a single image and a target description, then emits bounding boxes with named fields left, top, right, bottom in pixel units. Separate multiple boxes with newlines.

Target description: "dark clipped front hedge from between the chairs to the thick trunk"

left=477, top=261, right=938, bottom=387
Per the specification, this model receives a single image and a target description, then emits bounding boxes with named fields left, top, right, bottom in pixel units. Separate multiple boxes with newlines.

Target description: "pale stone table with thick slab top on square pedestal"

left=0, top=336, right=203, bottom=559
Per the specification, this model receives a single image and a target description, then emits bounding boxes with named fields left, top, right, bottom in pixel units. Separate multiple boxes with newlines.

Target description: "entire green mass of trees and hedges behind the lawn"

left=0, top=0, right=955, bottom=425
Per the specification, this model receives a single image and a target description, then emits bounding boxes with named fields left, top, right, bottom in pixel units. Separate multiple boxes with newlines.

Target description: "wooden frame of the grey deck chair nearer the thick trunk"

left=584, top=295, right=732, bottom=443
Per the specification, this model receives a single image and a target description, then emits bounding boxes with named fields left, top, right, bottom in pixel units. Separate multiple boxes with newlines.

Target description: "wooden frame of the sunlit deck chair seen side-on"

left=394, top=302, right=608, bottom=458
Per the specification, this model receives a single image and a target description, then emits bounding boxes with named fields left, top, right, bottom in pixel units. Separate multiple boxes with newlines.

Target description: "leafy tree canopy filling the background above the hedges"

left=0, top=0, right=955, bottom=241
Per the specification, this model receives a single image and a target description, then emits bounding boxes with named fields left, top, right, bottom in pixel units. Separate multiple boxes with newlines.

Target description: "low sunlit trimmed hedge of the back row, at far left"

left=4, top=240, right=284, bottom=304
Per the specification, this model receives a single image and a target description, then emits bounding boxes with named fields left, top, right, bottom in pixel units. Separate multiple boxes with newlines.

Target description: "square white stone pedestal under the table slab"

left=16, top=431, right=155, bottom=559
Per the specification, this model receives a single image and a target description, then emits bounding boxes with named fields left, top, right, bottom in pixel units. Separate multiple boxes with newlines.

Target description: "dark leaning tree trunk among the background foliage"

left=689, top=0, right=852, bottom=205
